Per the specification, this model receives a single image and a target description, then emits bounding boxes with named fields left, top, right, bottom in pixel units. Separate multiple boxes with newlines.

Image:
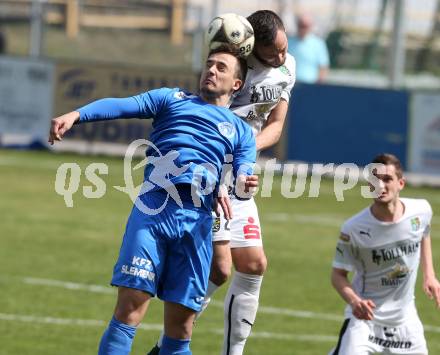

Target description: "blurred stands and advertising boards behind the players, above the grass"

left=0, top=0, right=440, bottom=174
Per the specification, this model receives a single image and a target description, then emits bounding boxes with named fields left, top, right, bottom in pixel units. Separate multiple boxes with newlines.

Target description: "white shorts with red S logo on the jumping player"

left=212, top=197, right=263, bottom=248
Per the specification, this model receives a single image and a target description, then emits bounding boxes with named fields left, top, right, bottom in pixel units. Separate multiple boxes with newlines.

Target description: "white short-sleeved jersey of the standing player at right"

left=333, top=198, right=432, bottom=325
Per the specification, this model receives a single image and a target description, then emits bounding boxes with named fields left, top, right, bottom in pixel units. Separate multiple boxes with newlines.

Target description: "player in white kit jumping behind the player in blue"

left=149, top=10, right=295, bottom=355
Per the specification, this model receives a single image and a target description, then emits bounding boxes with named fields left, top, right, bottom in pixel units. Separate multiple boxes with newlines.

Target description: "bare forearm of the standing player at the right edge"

left=420, top=234, right=440, bottom=308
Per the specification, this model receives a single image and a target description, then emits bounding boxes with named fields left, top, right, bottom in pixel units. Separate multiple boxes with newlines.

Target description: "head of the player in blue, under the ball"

left=200, top=53, right=241, bottom=97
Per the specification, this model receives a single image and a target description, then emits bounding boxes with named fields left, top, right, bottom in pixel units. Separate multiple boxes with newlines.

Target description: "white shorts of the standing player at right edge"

left=330, top=314, right=428, bottom=355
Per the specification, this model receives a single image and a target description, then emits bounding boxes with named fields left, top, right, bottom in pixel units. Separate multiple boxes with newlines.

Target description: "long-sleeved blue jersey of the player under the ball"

left=78, top=88, right=256, bottom=206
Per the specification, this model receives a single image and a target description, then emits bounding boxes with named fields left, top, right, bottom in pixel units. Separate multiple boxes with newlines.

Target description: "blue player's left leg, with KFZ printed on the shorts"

left=104, top=194, right=166, bottom=355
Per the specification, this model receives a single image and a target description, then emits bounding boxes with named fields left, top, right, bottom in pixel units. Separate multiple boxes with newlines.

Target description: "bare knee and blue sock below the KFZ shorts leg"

left=98, top=287, right=151, bottom=355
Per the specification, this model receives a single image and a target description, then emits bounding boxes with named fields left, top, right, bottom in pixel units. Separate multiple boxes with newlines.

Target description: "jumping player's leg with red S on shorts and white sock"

left=223, top=199, right=267, bottom=355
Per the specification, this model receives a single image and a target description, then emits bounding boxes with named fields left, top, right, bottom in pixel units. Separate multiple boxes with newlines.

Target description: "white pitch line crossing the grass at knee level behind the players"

left=23, top=277, right=440, bottom=336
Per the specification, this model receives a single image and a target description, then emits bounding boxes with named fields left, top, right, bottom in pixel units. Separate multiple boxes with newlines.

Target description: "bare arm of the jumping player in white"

left=256, top=99, right=289, bottom=150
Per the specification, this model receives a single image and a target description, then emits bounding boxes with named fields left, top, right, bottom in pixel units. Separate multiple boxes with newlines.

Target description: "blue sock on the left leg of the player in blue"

left=98, top=316, right=136, bottom=355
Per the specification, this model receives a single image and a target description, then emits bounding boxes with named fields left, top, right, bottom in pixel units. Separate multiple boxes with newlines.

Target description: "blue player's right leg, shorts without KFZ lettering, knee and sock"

left=157, top=206, right=212, bottom=355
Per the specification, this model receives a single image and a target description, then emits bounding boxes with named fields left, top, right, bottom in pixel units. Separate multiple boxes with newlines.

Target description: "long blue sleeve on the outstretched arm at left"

left=77, top=88, right=172, bottom=122
